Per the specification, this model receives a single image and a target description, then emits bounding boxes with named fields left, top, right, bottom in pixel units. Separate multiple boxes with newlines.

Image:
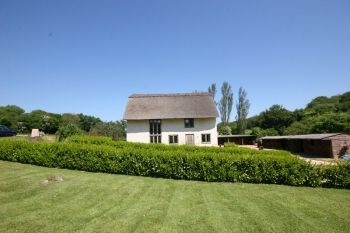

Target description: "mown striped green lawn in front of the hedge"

left=0, top=161, right=350, bottom=232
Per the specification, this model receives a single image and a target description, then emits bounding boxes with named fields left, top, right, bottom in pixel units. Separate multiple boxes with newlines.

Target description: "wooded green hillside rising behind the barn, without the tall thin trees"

left=246, top=92, right=350, bottom=137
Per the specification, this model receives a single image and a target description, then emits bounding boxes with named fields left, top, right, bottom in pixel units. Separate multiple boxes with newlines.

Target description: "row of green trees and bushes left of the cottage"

left=0, top=105, right=126, bottom=139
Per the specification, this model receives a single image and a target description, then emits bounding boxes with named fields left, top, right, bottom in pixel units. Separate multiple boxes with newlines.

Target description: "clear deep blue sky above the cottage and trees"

left=0, top=0, right=350, bottom=120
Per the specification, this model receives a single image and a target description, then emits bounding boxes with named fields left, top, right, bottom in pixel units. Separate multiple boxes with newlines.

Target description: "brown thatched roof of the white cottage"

left=123, top=92, right=218, bottom=120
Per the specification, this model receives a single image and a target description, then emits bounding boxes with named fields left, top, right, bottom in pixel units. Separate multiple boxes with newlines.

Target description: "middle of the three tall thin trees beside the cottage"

left=219, top=82, right=233, bottom=124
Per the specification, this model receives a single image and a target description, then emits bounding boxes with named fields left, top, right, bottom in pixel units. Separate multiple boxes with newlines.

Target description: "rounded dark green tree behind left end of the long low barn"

left=259, top=104, right=295, bottom=135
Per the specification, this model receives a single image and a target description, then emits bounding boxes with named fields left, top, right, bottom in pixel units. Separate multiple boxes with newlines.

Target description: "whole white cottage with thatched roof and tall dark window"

left=124, top=93, right=218, bottom=146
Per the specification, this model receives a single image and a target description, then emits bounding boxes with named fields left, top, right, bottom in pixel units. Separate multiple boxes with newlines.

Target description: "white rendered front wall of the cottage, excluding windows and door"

left=126, top=118, right=218, bottom=146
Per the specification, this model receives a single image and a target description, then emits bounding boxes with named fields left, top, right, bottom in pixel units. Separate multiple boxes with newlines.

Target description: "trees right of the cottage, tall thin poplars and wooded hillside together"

left=208, top=82, right=350, bottom=137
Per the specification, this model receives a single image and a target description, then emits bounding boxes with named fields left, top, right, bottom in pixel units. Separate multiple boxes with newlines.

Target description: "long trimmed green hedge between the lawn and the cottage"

left=0, top=140, right=350, bottom=188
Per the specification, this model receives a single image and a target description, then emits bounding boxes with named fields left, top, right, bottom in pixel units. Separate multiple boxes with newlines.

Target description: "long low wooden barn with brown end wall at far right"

left=261, top=133, right=350, bottom=158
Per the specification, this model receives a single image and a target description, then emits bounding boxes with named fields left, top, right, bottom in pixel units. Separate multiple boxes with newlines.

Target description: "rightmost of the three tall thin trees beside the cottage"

left=236, top=87, right=250, bottom=134
